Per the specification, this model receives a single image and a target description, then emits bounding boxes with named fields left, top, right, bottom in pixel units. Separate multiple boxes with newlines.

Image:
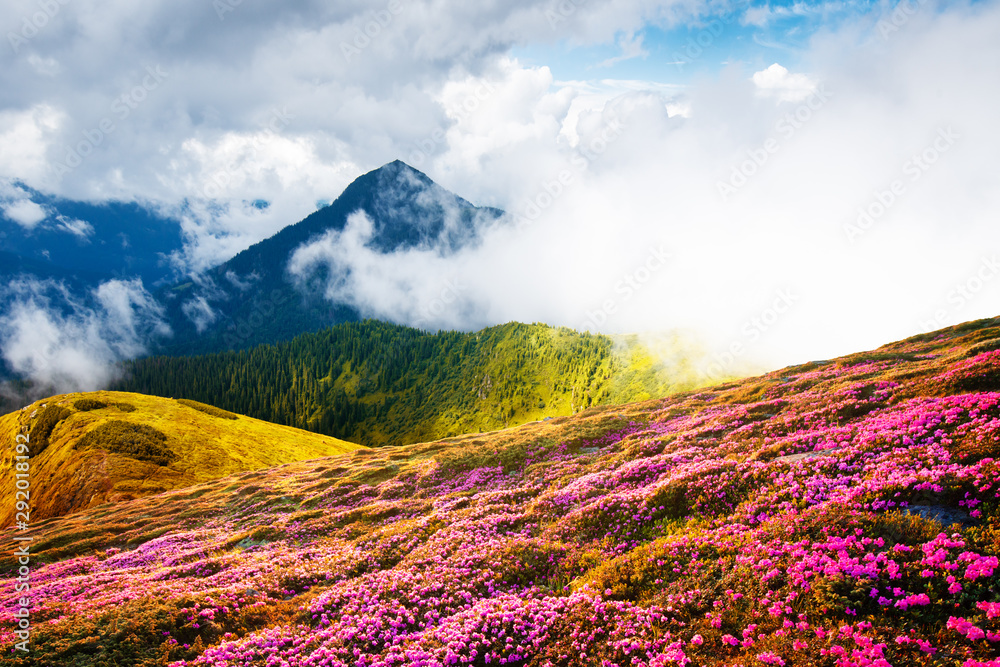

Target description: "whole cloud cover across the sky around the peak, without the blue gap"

left=0, top=0, right=1000, bottom=392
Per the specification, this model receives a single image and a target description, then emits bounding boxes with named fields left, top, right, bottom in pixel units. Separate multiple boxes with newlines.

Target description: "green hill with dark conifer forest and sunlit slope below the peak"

left=116, top=321, right=716, bottom=446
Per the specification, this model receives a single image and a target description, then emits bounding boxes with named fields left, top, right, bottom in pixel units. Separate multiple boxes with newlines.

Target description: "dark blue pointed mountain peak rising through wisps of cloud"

left=166, top=160, right=503, bottom=353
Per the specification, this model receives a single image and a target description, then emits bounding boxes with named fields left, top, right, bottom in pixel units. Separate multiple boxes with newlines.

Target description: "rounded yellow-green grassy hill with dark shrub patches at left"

left=0, top=391, right=358, bottom=525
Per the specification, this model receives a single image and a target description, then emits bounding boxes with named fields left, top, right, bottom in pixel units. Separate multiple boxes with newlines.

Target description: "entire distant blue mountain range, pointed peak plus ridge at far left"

left=0, top=160, right=503, bottom=355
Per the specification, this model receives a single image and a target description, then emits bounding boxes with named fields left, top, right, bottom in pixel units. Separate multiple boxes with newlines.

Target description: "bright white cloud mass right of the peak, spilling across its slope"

left=286, top=4, right=1000, bottom=376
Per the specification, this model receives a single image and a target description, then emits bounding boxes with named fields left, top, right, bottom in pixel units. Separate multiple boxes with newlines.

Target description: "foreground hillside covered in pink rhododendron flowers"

left=0, top=320, right=1000, bottom=667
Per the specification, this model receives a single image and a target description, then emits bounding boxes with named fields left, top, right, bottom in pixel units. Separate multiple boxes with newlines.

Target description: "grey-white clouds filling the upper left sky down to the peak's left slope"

left=0, top=0, right=702, bottom=271
